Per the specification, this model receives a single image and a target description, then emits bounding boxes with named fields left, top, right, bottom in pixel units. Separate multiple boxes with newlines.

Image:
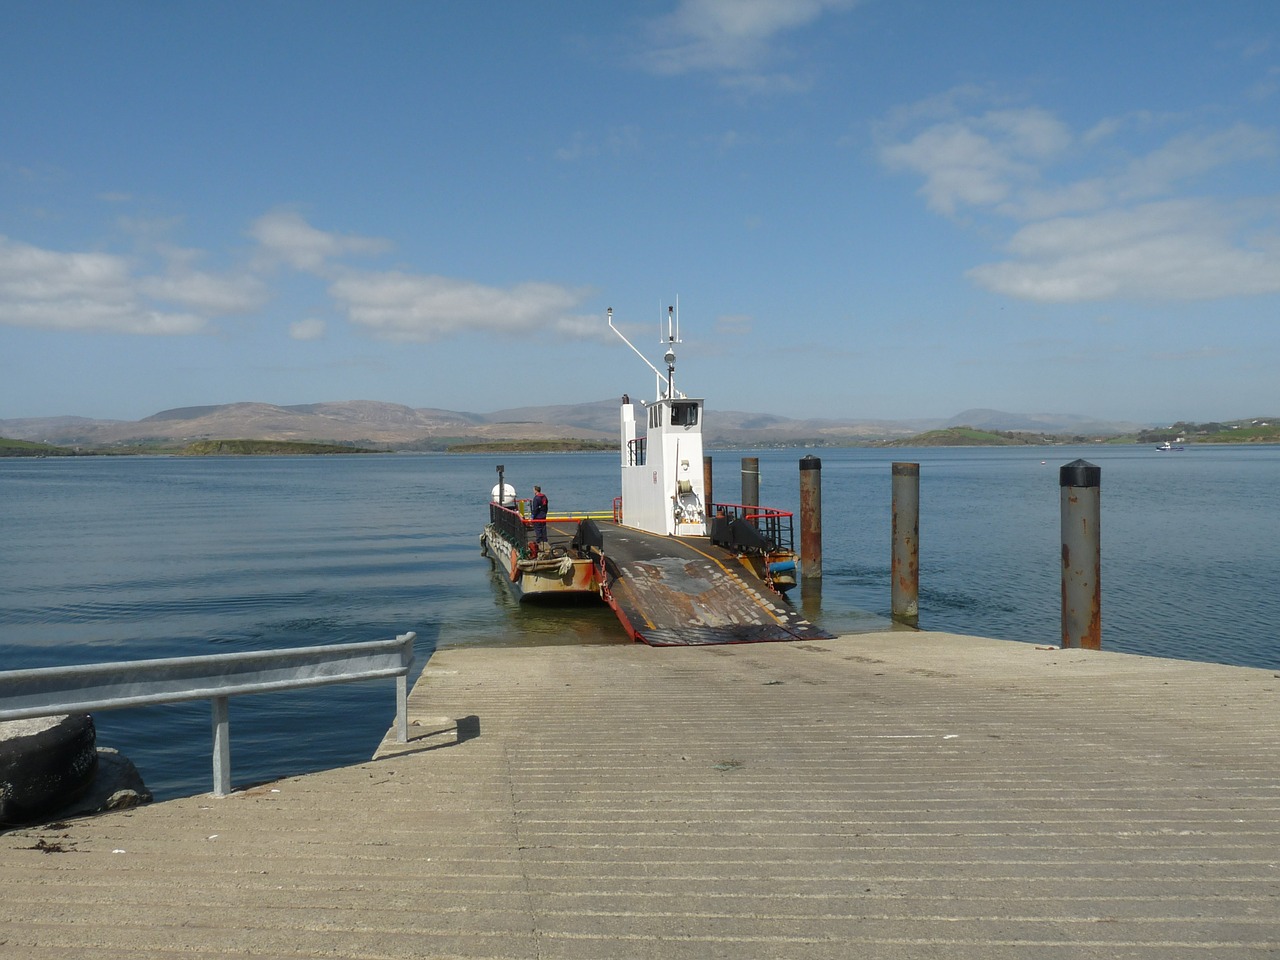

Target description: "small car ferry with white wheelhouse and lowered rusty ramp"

left=480, top=300, right=829, bottom=643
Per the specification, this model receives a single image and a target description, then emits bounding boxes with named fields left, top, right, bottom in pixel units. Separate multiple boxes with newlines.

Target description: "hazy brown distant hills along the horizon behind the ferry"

left=0, top=398, right=1143, bottom=449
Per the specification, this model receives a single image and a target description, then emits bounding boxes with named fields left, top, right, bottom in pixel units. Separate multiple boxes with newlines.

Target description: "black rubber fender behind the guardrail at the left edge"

left=0, top=713, right=97, bottom=828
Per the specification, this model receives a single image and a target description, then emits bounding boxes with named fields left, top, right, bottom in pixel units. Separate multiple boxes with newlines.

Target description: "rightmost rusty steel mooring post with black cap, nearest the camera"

left=1057, top=460, right=1102, bottom=650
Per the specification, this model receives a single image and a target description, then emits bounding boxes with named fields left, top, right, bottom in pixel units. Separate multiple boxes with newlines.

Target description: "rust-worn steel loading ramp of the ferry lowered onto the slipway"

left=599, top=524, right=835, bottom=646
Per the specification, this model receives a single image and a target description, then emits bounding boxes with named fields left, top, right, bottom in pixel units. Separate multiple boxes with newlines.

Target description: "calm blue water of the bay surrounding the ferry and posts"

left=0, top=445, right=1280, bottom=797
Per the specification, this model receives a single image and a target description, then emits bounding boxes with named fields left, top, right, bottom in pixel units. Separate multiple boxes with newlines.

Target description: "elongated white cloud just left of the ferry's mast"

left=329, top=271, right=593, bottom=342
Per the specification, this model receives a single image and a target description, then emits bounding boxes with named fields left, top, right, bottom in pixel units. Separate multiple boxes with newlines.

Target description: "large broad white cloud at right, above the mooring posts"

left=877, top=88, right=1280, bottom=302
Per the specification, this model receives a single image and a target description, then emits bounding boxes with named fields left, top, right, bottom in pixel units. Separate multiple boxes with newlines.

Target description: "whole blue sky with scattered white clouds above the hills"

left=0, top=0, right=1280, bottom=424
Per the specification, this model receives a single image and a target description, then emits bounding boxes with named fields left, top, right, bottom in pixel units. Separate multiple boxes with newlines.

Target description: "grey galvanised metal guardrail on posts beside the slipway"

left=0, top=632, right=417, bottom=796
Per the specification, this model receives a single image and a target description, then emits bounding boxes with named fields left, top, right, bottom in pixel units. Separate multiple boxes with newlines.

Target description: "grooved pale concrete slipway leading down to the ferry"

left=0, top=632, right=1280, bottom=960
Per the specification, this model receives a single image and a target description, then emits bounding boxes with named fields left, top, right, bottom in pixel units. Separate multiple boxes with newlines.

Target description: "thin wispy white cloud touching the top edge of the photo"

left=640, top=0, right=858, bottom=90
